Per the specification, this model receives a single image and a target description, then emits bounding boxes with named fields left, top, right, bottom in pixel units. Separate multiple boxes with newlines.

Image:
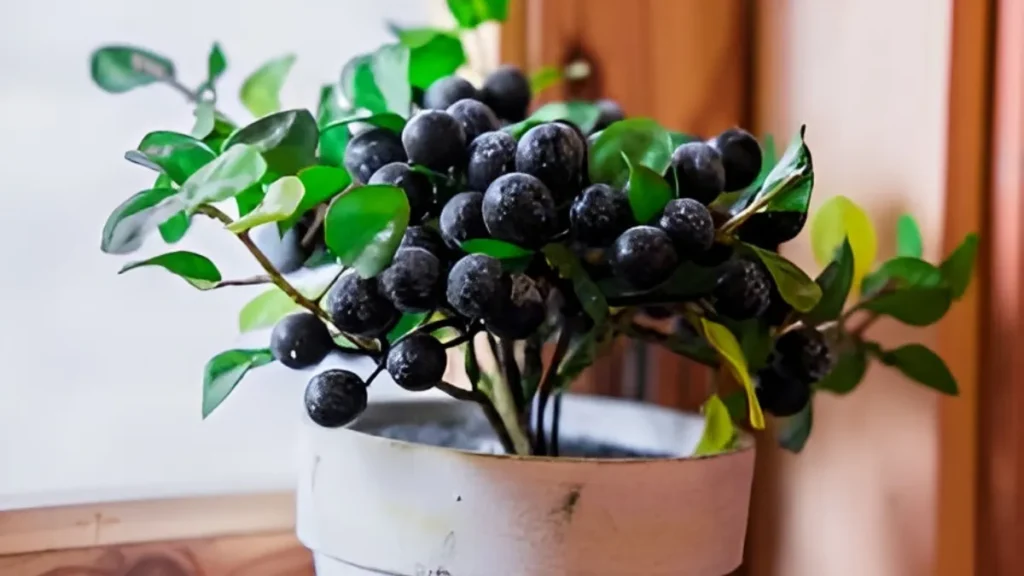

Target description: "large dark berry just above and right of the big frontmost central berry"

left=515, top=122, right=586, bottom=204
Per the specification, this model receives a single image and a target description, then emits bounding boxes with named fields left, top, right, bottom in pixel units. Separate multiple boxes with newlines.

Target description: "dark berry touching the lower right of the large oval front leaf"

left=377, top=243, right=444, bottom=313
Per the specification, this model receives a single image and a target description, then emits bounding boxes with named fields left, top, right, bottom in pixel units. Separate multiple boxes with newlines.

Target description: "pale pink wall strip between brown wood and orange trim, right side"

left=758, top=0, right=950, bottom=576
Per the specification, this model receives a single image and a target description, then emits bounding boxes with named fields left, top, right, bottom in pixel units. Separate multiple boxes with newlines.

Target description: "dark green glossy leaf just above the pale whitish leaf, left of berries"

left=222, top=110, right=319, bottom=176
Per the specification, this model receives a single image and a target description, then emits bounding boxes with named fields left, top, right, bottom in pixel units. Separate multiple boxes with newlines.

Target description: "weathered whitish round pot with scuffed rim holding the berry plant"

left=298, top=383, right=754, bottom=576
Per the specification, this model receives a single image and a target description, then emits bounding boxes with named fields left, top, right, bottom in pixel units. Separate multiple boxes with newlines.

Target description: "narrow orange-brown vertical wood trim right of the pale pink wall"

left=935, top=0, right=991, bottom=576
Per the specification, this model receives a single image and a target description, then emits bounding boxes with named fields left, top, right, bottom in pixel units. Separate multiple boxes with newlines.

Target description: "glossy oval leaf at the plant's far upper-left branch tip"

left=90, top=46, right=174, bottom=93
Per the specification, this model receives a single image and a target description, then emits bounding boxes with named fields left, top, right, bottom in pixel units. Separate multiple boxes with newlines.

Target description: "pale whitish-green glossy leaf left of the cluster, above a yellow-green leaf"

left=178, top=145, right=266, bottom=212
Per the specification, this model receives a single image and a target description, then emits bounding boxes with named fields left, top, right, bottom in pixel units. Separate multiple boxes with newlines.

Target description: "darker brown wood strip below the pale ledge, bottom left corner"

left=0, top=532, right=313, bottom=576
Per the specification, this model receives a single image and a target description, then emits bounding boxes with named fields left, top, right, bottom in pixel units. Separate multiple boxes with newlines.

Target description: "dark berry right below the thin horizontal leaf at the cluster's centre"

left=447, top=254, right=510, bottom=318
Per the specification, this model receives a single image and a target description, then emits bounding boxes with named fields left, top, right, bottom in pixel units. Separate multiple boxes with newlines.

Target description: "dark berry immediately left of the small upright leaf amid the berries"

left=569, top=184, right=636, bottom=246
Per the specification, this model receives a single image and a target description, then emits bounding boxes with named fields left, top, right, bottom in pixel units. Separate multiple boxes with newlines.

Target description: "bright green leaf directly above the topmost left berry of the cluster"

left=391, top=27, right=466, bottom=89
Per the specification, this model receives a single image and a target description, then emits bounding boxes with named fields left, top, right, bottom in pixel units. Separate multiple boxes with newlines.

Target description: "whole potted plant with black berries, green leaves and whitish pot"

left=91, top=0, right=977, bottom=576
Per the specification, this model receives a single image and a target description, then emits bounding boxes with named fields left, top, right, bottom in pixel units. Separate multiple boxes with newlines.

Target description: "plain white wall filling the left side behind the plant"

left=0, top=0, right=437, bottom=509
